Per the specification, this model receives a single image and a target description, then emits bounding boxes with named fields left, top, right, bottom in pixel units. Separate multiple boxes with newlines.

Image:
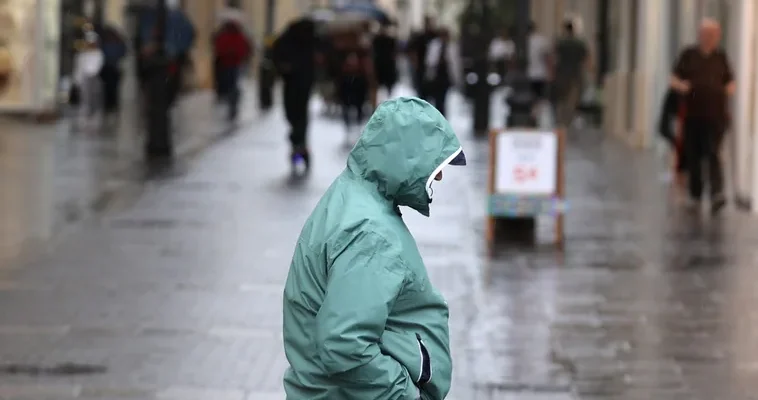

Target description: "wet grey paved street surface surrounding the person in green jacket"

left=0, top=83, right=758, bottom=400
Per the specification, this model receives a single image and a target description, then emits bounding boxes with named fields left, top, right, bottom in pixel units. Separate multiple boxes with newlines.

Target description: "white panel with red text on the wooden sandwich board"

left=495, top=131, right=558, bottom=196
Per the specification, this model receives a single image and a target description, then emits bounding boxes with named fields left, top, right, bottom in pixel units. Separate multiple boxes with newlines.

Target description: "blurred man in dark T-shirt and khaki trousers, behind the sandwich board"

left=553, top=18, right=590, bottom=128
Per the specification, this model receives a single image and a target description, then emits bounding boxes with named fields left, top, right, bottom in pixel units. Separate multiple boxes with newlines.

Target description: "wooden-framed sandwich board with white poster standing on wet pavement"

left=487, top=129, right=566, bottom=245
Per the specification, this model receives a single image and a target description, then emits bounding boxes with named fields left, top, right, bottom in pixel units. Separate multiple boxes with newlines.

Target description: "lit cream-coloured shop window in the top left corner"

left=0, top=0, right=61, bottom=112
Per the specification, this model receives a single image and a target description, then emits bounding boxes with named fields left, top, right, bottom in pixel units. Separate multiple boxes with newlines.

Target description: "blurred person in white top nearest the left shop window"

left=74, top=30, right=104, bottom=127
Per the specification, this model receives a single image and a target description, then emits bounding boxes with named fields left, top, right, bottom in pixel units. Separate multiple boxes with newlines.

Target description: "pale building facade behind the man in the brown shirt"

left=532, top=0, right=758, bottom=212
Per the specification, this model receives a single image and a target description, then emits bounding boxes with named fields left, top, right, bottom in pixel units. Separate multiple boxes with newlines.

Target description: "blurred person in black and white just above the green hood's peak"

left=424, top=28, right=462, bottom=115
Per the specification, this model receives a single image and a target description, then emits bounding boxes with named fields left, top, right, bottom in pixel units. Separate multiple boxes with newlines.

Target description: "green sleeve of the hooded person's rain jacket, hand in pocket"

left=316, top=234, right=419, bottom=400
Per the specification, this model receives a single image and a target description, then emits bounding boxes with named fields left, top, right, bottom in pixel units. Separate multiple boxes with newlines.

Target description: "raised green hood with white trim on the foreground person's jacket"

left=347, top=97, right=465, bottom=216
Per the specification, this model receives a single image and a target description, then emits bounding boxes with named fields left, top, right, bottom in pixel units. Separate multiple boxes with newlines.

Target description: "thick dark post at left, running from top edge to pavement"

left=145, top=0, right=174, bottom=161
